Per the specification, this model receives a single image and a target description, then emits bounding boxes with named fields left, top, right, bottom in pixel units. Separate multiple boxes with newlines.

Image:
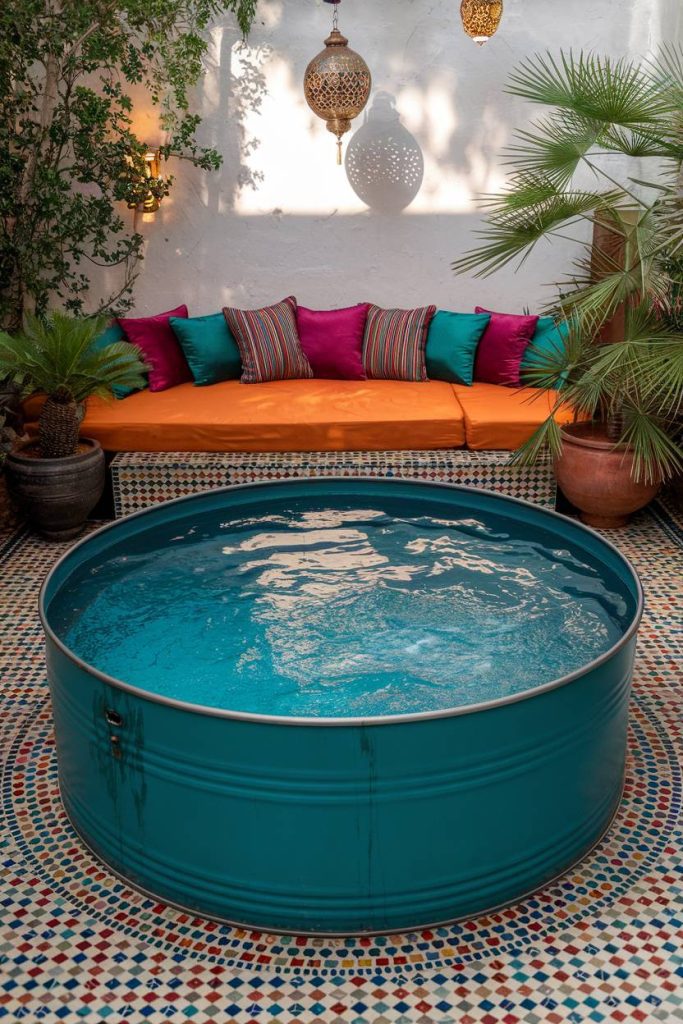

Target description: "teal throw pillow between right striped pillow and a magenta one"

left=425, top=309, right=490, bottom=385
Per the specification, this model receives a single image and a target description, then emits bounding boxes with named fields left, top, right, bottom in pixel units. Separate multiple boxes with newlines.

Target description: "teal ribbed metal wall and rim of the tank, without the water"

left=41, top=480, right=642, bottom=933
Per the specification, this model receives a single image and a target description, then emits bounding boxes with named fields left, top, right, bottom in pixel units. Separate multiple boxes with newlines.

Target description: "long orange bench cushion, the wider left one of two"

left=28, top=380, right=465, bottom=452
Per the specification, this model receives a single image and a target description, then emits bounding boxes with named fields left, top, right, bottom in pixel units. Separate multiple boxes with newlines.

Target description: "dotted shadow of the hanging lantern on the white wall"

left=345, top=91, right=425, bottom=213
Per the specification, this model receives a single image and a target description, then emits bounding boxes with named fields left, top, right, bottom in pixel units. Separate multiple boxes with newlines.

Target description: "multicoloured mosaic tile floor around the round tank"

left=0, top=505, right=683, bottom=1024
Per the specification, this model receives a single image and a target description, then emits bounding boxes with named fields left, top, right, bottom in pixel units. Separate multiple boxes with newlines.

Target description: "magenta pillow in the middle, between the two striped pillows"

left=297, top=302, right=370, bottom=381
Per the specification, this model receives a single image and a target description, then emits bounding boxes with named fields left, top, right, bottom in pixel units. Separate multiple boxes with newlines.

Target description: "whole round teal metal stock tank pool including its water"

left=41, top=478, right=642, bottom=934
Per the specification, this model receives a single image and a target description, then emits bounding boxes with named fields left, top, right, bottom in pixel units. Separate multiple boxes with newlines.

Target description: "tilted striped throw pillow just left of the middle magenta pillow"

left=223, top=295, right=313, bottom=384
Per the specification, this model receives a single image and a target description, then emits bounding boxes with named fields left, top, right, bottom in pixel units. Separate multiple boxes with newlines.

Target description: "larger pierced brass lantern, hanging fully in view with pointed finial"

left=303, top=0, right=372, bottom=164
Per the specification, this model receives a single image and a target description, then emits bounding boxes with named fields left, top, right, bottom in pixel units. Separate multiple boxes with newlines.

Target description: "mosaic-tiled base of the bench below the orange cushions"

left=111, top=450, right=555, bottom=517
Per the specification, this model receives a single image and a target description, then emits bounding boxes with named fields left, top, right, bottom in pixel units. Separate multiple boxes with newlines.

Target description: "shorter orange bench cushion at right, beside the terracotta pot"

left=451, top=384, right=573, bottom=452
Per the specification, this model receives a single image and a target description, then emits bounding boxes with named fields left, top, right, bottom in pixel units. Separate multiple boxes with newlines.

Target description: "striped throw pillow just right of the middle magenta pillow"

left=362, top=306, right=436, bottom=381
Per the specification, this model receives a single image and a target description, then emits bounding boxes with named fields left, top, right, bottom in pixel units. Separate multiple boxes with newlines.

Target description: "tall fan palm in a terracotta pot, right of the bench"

left=454, top=49, right=683, bottom=526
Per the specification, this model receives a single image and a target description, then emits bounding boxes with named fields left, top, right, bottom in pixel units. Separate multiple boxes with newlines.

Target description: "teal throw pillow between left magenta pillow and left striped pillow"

left=169, top=313, right=242, bottom=387
